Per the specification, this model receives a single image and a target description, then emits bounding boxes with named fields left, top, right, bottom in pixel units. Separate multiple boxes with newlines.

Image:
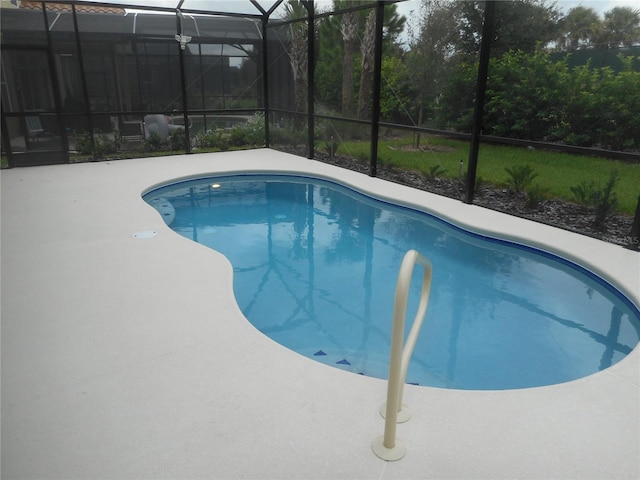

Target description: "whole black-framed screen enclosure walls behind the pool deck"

left=1, top=0, right=640, bottom=246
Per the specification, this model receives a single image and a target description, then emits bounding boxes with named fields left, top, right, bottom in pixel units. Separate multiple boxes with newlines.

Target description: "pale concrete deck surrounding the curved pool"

left=0, top=149, right=640, bottom=480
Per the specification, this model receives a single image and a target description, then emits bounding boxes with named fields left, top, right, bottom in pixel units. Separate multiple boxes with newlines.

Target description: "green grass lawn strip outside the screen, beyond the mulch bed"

left=338, top=135, right=640, bottom=215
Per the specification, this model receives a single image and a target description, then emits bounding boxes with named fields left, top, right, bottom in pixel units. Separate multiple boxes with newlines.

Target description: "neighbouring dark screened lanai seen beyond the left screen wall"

left=2, top=2, right=277, bottom=166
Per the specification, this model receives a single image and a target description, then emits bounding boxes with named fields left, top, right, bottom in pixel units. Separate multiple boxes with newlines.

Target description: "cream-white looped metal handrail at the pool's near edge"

left=371, top=250, right=433, bottom=461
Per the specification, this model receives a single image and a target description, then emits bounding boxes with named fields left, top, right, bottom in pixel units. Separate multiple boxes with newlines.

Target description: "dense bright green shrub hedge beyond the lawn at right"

left=431, top=50, right=640, bottom=151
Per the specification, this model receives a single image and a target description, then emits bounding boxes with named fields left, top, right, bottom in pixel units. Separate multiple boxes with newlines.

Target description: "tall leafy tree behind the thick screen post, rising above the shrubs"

left=407, top=0, right=559, bottom=130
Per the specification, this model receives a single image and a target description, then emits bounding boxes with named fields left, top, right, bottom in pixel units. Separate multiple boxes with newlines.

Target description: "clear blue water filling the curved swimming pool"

left=144, top=175, right=640, bottom=389
